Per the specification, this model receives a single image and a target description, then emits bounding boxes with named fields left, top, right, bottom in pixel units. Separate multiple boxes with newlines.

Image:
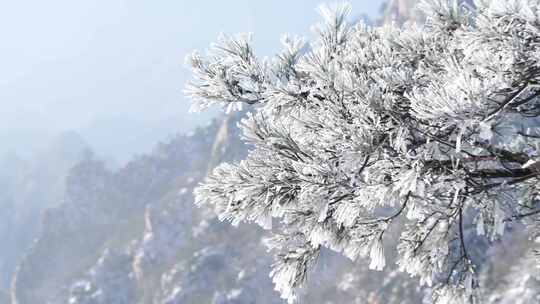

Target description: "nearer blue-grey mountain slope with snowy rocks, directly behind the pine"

left=7, top=113, right=419, bottom=304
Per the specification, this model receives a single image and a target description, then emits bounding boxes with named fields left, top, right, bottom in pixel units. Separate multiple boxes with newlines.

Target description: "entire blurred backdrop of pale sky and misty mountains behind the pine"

left=0, top=0, right=442, bottom=304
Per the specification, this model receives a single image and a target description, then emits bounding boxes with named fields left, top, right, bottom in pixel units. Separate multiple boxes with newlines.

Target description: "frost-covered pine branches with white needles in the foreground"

left=186, top=0, right=540, bottom=303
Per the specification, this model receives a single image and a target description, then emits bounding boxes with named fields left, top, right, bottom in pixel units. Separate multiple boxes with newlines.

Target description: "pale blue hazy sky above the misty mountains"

left=0, top=0, right=382, bottom=159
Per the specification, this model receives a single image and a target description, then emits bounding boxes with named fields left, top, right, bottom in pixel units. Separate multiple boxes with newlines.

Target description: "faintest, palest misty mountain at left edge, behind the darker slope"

left=0, top=132, right=88, bottom=290
